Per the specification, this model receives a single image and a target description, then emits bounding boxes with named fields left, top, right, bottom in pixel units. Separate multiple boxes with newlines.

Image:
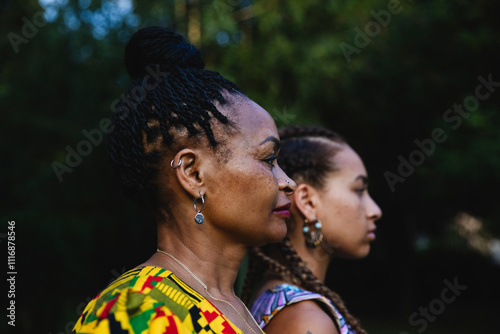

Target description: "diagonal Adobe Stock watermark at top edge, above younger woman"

left=339, top=0, right=411, bottom=64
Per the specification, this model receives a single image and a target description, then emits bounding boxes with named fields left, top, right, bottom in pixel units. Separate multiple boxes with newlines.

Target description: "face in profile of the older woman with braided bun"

left=205, top=96, right=295, bottom=245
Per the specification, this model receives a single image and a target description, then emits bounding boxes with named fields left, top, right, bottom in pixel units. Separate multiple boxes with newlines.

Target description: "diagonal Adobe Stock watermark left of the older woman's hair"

left=51, top=65, right=169, bottom=183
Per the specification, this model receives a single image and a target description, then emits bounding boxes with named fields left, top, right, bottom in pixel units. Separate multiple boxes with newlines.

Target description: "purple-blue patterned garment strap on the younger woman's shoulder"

left=250, top=284, right=356, bottom=334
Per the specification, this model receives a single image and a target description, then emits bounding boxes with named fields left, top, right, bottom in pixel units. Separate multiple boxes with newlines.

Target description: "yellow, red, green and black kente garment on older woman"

left=73, top=266, right=243, bottom=334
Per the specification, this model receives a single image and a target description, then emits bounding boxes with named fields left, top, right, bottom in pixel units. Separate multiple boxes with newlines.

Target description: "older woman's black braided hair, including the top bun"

left=109, top=26, right=243, bottom=207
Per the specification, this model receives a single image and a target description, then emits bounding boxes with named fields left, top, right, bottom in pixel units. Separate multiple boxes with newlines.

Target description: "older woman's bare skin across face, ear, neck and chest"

left=141, top=94, right=296, bottom=333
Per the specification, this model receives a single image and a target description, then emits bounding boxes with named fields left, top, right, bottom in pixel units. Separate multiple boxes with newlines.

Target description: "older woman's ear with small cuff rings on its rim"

left=172, top=148, right=206, bottom=198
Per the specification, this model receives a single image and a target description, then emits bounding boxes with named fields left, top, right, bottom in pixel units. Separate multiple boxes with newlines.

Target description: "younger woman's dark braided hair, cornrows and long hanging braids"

left=242, top=126, right=366, bottom=334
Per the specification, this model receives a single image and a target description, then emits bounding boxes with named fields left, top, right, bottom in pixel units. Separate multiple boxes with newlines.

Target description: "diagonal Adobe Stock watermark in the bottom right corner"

left=399, top=277, right=468, bottom=334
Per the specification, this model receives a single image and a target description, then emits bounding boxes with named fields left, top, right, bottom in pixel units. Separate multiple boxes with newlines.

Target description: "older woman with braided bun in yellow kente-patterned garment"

left=75, top=27, right=296, bottom=333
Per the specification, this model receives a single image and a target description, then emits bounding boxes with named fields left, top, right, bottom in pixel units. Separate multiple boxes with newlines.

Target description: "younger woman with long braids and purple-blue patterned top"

left=244, top=126, right=382, bottom=334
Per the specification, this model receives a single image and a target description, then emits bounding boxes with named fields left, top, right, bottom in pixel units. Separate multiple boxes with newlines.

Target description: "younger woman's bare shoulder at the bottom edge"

left=264, top=300, right=339, bottom=334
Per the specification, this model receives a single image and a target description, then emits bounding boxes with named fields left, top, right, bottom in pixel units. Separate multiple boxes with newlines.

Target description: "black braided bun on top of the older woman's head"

left=125, top=26, right=205, bottom=79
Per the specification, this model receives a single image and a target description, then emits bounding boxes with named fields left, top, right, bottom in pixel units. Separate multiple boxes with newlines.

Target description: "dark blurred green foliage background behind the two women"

left=0, top=0, right=500, bottom=334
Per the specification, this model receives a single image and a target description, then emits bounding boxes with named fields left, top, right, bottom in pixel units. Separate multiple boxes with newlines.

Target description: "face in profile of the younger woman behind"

left=317, top=146, right=382, bottom=258
